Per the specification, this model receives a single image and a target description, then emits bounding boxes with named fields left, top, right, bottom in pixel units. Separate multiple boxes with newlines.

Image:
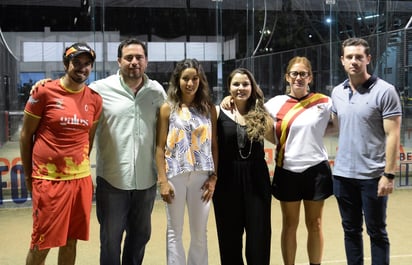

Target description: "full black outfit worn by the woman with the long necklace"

left=213, top=110, right=271, bottom=265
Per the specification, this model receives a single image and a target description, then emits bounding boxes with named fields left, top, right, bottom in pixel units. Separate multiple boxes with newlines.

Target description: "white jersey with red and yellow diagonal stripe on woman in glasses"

left=265, top=93, right=332, bottom=172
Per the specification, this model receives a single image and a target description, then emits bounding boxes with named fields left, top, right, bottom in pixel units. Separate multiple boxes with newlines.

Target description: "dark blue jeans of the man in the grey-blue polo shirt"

left=333, top=176, right=389, bottom=265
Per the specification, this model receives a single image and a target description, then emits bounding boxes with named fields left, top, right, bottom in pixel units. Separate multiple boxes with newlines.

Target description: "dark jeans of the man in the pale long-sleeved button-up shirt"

left=96, top=177, right=156, bottom=265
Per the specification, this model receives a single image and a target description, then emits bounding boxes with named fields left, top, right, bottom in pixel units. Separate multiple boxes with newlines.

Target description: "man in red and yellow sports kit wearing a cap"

left=20, top=43, right=102, bottom=265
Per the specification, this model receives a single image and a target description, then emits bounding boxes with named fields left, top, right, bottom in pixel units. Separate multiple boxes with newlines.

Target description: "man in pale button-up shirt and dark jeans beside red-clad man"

left=90, top=39, right=166, bottom=265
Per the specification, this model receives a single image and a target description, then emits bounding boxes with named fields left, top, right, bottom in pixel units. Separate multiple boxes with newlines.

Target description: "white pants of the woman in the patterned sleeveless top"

left=166, top=171, right=210, bottom=265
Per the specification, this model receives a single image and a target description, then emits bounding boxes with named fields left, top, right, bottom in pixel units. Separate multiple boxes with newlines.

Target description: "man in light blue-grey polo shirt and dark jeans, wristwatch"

left=332, top=38, right=402, bottom=265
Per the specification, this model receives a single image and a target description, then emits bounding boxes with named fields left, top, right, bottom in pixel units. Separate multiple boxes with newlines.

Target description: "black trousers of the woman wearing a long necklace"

left=213, top=184, right=271, bottom=265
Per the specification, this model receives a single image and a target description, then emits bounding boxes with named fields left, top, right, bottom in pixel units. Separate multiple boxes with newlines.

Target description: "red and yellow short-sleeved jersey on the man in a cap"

left=24, top=80, right=102, bottom=180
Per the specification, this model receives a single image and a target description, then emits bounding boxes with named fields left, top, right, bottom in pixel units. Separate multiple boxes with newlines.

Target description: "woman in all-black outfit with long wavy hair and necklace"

left=213, top=68, right=274, bottom=265
